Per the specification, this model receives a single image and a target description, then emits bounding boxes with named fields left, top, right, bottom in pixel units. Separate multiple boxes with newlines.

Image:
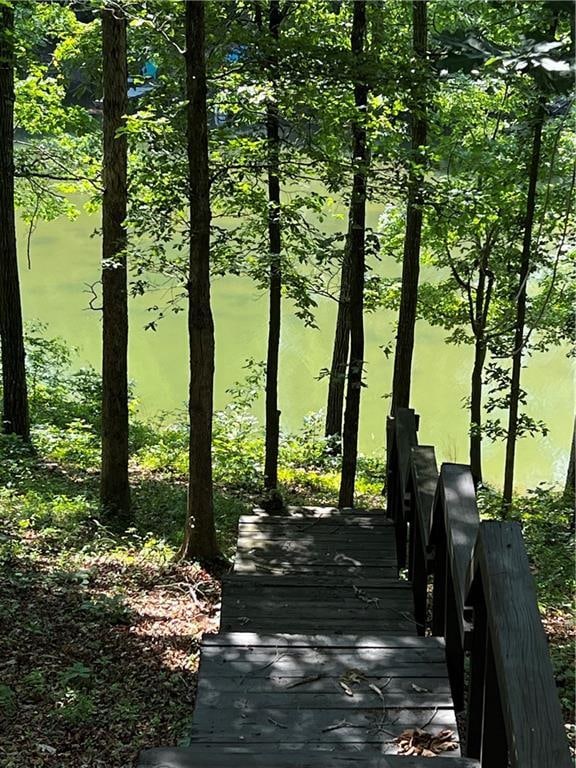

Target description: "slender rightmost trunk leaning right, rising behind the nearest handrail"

left=502, top=104, right=545, bottom=512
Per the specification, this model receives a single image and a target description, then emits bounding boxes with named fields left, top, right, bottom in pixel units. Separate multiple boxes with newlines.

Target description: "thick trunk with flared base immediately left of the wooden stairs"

left=180, top=0, right=220, bottom=561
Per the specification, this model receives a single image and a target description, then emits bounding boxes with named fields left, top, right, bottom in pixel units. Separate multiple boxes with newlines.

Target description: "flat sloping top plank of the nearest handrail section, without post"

left=474, top=522, right=572, bottom=768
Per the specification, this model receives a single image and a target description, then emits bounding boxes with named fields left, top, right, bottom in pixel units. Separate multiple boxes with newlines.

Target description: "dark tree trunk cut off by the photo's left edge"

left=0, top=5, right=30, bottom=440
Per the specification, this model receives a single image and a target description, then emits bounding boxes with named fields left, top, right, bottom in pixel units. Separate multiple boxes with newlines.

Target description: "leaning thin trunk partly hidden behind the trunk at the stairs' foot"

left=324, top=220, right=351, bottom=444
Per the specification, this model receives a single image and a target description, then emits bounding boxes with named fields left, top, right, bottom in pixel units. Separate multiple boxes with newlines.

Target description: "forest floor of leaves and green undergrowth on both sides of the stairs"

left=0, top=446, right=575, bottom=768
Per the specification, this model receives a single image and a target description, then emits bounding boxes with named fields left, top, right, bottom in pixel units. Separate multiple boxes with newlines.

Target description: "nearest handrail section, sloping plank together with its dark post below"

left=468, top=521, right=572, bottom=768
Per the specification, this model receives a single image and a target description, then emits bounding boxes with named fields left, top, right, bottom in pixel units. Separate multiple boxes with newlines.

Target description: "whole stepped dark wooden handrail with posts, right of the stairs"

left=387, top=409, right=571, bottom=768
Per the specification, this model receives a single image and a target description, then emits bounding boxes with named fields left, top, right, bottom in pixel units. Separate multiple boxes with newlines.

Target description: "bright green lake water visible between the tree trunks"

left=20, top=205, right=574, bottom=488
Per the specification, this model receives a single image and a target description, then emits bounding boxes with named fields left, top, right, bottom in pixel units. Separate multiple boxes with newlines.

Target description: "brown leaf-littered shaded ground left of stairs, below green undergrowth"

left=0, top=533, right=220, bottom=768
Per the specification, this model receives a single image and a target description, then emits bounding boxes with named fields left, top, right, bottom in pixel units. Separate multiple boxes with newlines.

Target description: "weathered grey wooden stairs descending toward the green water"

left=138, top=507, right=479, bottom=768
